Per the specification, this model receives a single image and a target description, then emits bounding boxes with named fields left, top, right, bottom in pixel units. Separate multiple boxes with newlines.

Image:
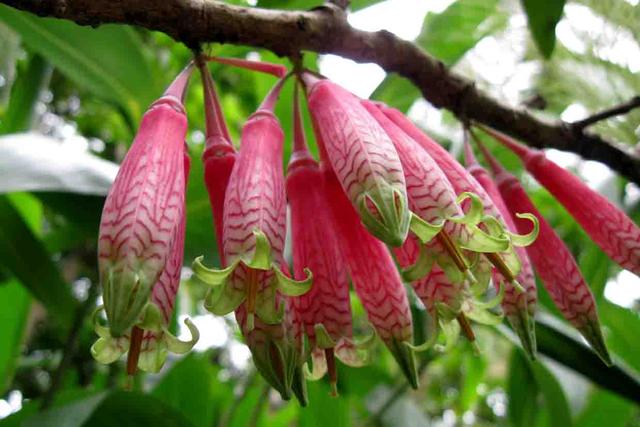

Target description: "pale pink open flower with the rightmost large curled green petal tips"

left=379, top=106, right=537, bottom=298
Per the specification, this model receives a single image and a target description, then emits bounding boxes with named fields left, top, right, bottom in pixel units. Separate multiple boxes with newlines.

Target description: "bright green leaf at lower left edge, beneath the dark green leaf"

left=0, top=280, right=31, bottom=395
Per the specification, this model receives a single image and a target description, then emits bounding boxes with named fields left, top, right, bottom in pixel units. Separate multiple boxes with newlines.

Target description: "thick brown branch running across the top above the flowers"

left=5, top=0, right=640, bottom=184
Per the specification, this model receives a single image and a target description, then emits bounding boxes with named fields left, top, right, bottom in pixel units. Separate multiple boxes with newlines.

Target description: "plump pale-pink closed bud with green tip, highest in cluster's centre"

left=302, top=73, right=410, bottom=246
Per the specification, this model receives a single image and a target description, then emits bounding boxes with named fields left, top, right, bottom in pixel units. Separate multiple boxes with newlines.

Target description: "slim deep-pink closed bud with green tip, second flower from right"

left=484, top=140, right=611, bottom=365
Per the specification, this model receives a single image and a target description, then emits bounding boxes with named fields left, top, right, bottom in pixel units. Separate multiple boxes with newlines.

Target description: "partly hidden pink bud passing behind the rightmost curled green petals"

left=464, top=141, right=538, bottom=358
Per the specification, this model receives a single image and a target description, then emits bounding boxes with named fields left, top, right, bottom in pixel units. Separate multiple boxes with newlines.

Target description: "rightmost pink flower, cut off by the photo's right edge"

left=482, top=127, right=640, bottom=275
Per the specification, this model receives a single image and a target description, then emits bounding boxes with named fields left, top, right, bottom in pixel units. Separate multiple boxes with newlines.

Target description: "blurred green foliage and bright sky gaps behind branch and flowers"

left=0, top=0, right=640, bottom=427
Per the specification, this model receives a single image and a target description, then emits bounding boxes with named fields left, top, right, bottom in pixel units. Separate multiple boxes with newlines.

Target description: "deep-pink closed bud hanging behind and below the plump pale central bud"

left=321, top=164, right=418, bottom=388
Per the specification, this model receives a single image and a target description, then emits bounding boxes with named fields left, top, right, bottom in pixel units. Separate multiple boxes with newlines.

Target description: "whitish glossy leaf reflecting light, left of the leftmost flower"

left=0, top=133, right=118, bottom=195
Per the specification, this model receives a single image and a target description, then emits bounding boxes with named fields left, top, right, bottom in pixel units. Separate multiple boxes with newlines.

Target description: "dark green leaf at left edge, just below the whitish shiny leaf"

left=0, top=196, right=76, bottom=328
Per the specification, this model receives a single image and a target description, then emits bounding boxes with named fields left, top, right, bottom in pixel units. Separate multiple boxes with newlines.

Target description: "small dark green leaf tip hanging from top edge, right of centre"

left=521, top=0, right=565, bottom=58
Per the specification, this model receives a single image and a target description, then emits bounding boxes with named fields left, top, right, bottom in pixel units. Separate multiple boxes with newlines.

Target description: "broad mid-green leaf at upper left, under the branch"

left=0, top=6, right=161, bottom=123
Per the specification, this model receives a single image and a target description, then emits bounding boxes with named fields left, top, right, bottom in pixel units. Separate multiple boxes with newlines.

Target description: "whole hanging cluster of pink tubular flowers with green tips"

left=92, top=58, right=640, bottom=404
